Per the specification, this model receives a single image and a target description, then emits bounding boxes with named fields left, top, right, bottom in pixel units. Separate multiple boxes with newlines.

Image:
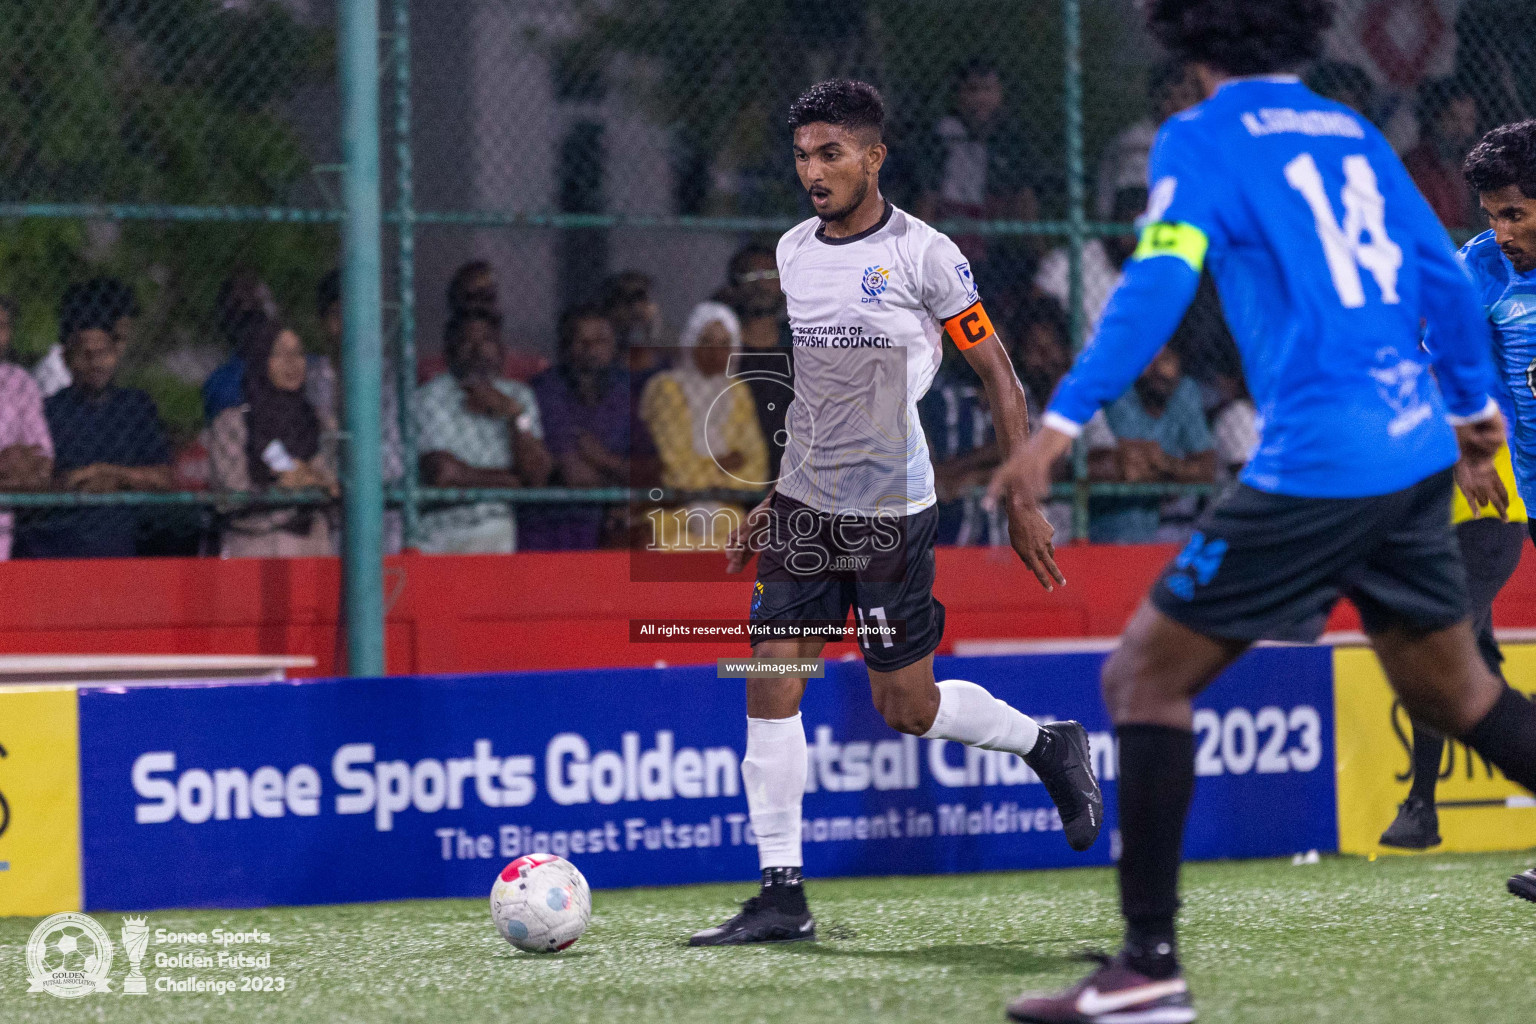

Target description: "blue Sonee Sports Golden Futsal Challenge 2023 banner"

left=29, top=648, right=1336, bottom=910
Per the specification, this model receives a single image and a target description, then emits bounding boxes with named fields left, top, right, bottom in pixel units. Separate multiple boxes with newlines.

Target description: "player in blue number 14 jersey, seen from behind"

left=992, top=0, right=1536, bottom=1024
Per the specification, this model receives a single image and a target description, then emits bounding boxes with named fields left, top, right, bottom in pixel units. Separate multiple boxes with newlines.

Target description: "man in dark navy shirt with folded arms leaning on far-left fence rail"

left=15, top=302, right=175, bottom=559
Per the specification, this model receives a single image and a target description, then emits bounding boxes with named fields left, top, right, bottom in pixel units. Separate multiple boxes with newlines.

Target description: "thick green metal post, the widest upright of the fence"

left=336, top=0, right=384, bottom=676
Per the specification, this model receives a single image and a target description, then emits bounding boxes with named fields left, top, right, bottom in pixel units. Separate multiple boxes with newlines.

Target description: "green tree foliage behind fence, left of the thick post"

left=0, top=0, right=336, bottom=423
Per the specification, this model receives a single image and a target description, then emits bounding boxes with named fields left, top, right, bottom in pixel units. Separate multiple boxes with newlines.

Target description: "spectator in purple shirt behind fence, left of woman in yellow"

left=519, top=306, right=633, bottom=551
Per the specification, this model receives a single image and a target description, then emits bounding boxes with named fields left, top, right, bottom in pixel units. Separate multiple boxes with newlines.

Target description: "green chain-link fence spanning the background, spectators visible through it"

left=0, top=0, right=1536, bottom=556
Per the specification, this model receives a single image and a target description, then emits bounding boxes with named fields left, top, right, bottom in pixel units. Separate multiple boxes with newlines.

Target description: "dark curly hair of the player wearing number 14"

left=1147, top=0, right=1333, bottom=75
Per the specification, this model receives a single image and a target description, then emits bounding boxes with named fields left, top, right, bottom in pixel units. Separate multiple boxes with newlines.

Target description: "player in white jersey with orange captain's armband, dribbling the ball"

left=690, top=80, right=1103, bottom=946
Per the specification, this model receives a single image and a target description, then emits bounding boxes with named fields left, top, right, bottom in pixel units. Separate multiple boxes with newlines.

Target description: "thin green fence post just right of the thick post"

left=395, top=0, right=421, bottom=548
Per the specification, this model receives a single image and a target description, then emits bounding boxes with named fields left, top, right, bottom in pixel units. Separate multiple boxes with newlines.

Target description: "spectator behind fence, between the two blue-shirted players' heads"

left=1402, top=77, right=1484, bottom=232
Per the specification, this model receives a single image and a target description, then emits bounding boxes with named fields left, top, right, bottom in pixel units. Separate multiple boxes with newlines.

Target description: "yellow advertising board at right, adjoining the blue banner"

left=1333, top=643, right=1536, bottom=854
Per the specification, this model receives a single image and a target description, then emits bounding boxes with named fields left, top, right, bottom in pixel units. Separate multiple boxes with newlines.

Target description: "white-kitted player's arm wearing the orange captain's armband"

left=945, top=302, right=1066, bottom=590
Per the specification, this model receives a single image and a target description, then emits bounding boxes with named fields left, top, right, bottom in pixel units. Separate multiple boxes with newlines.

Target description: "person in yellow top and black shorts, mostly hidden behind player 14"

left=1381, top=445, right=1530, bottom=849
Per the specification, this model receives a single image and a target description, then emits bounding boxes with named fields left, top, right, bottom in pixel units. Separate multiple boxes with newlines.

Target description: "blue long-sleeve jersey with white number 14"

left=1044, top=75, right=1493, bottom=497
